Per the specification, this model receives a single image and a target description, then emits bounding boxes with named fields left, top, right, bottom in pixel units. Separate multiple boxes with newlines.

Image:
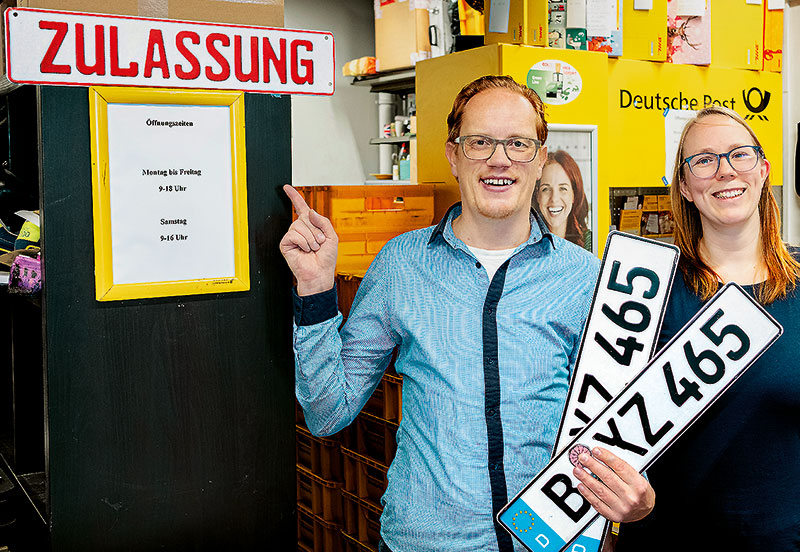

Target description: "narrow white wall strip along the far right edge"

left=783, top=0, right=800, bottom=244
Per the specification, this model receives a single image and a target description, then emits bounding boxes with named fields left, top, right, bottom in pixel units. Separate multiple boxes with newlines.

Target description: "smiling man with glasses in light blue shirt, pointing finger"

left=281, top=76, right=654, bottom=552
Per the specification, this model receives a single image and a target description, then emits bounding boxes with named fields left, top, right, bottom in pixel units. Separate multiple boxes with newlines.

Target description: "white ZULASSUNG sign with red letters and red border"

left=5, top=8, right=335, bottom=95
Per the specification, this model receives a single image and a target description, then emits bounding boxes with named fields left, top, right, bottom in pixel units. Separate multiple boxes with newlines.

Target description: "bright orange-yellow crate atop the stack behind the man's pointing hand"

left=297, top=185, right=433, bottom=275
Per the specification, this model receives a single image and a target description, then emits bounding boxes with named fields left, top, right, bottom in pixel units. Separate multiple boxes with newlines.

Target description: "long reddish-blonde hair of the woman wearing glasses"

left=671, top=106, right=800, bottom=304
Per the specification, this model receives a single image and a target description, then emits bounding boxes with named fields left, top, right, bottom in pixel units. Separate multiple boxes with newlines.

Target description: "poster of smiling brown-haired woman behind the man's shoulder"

left=533, top=124, right=597, bottom=253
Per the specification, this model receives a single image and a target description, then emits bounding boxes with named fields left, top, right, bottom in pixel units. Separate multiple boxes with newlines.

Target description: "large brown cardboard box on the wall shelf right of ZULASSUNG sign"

left=375, top=0, right=431, bottom=72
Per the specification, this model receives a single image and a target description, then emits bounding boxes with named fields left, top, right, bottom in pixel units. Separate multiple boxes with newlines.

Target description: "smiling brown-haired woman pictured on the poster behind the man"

left=533, top=150, right=592, bottom=251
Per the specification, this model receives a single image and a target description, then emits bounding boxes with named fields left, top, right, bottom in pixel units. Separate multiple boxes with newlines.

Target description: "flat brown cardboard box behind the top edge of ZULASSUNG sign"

left=17, top=0, right=283, bottom=27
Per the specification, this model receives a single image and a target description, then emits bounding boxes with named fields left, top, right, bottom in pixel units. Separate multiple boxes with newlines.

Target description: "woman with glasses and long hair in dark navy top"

left=617, top=107, right=800, bottom=552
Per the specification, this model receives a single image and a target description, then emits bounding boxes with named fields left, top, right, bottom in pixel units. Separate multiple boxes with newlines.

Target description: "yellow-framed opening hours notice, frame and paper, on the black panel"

left=89, top=87, right=250, bottom=301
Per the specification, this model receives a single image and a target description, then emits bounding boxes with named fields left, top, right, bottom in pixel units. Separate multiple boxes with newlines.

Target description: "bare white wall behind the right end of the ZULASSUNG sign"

left=284, top=0, right=378, bottom=186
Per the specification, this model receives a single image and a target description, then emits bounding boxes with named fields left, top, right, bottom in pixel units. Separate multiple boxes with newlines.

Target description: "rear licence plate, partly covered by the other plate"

left=554, top=232, right=680, bottom=552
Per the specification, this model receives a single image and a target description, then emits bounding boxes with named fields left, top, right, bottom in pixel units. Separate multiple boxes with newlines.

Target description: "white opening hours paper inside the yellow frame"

left=108, top=103, right=235, bottom=284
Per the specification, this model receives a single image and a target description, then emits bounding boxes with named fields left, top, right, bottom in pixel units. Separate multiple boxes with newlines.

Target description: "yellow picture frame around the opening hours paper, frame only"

left=88, top=87, right=250, bottom=301
